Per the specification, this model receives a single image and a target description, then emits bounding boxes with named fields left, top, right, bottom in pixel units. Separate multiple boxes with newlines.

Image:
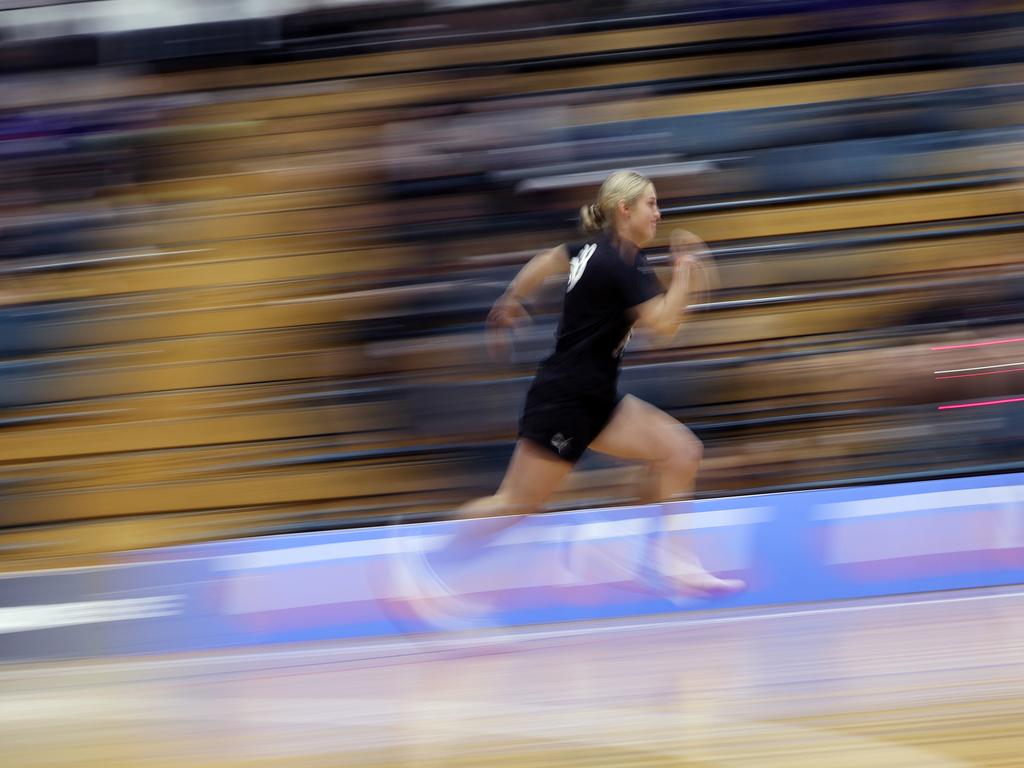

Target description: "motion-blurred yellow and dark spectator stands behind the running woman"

left=0, top=0, right=1024, bottom=568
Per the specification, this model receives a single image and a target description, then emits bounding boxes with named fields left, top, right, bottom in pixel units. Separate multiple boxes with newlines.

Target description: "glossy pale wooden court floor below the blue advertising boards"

left=0, top=587, right=1024, bottom=768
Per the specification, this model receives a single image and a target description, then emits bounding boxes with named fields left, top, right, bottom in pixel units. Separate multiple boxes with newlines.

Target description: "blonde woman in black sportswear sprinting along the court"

left=401, top=166, right=745, bottom=618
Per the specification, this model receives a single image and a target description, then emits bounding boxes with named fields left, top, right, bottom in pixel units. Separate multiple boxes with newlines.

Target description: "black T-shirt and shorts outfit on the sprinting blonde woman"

left=519, top=234, right=662, bottom=462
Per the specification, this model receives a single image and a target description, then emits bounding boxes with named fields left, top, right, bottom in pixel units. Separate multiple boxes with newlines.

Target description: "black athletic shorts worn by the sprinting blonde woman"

left=519, top=389, right=622, bottom=464
